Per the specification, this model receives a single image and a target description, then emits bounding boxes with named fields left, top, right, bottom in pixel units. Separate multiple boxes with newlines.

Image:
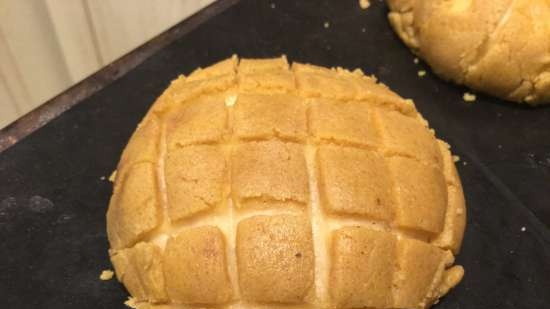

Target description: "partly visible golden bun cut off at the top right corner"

left=387, top=0, right=550, bottom=105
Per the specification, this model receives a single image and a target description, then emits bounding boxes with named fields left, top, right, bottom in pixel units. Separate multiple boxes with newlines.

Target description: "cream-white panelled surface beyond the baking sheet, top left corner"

left=0, top=0, right=214, bottom=128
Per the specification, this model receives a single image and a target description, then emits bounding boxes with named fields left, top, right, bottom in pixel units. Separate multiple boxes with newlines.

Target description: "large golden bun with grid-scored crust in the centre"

left=107, top=56, right=466, bottom=308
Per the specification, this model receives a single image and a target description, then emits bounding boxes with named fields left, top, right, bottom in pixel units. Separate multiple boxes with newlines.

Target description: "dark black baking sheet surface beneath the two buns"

left=0, top=0, right=550, bottom=309
